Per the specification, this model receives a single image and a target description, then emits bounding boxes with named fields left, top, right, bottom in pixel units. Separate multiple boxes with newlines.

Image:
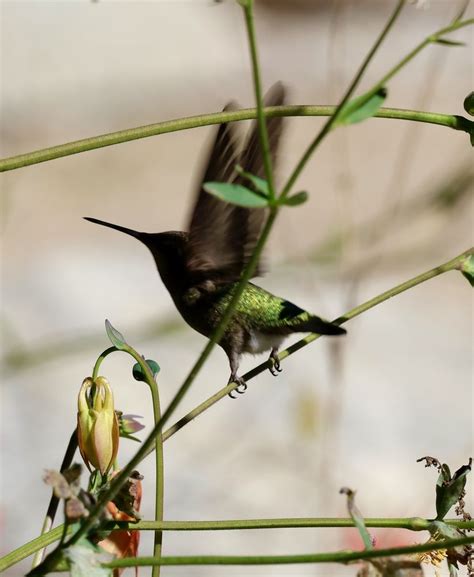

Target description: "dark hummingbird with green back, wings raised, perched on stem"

left=85, top=83, right=346, bottom=398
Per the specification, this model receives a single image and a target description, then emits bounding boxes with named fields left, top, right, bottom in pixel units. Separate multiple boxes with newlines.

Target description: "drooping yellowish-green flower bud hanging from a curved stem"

left=77, top=377, right=119, bottom=475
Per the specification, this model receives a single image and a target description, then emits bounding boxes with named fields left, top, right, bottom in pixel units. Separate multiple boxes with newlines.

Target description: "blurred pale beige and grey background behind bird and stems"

left=0, top=0, right=474, bottom=576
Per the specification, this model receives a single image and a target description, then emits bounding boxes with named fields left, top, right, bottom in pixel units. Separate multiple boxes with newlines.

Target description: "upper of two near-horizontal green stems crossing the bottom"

left=0, top=517, right=474, bottom=572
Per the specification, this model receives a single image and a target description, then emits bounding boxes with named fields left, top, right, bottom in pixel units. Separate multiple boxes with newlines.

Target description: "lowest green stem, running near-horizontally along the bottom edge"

left=104, top=535, right=474, bottom=568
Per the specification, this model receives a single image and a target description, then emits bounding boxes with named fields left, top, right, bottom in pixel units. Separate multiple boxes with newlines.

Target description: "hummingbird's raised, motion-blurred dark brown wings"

left=187, top=84, right=284, bottom=284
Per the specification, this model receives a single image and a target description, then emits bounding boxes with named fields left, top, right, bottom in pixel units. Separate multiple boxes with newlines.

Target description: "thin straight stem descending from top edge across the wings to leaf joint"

left=242, top=0, right=275, bottom=200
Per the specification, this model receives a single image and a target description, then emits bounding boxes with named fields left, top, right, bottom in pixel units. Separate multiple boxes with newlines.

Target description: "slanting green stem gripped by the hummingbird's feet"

left=157, top=248, right=474, bottom=441
